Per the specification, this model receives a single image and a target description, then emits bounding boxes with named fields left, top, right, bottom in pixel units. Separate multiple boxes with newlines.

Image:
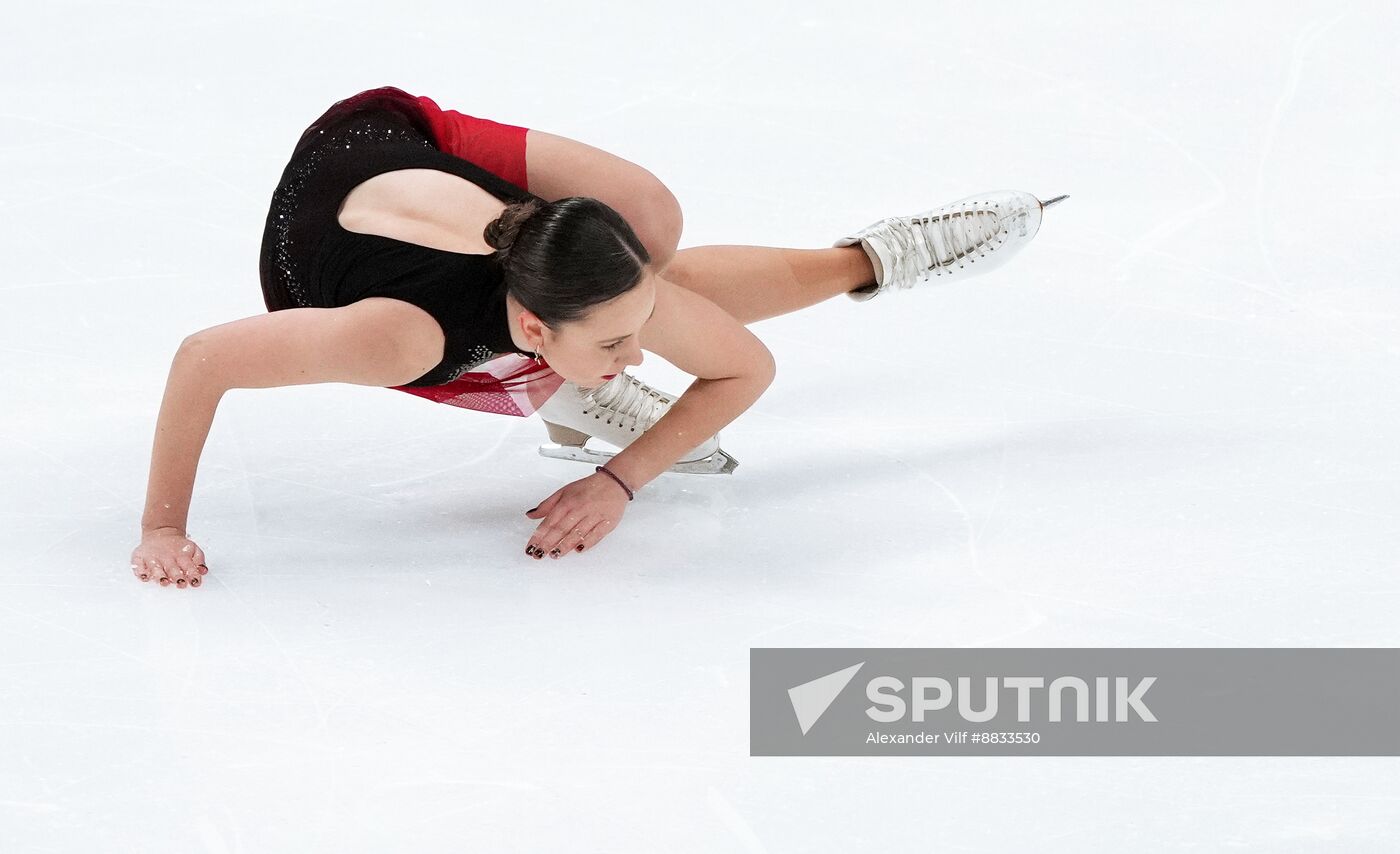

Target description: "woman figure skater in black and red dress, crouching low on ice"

left=132, top=87, right=1065, bottom=588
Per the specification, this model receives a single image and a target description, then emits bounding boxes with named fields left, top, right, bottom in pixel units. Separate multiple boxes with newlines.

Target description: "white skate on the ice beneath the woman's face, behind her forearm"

left=538, top=371, right=739, bottom=475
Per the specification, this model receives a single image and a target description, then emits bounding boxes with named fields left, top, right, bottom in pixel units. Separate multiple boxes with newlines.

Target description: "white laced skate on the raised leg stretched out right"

left=832, top=190, right=1068, bottom=302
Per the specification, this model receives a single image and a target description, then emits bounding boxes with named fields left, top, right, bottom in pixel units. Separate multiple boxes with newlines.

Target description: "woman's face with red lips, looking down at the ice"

left=540, top=270, right=657, bottom=388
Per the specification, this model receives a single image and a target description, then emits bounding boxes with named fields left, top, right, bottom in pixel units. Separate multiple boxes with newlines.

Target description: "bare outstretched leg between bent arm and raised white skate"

left=661, top=246, right=875, bottom=325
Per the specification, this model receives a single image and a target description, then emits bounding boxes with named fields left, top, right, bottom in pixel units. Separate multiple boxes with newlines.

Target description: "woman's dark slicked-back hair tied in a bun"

left=483, top=196, right=651, bottom=329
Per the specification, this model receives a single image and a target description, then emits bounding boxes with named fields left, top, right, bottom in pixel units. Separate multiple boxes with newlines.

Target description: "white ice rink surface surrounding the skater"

left=0, top=0, right=1400, bottom=854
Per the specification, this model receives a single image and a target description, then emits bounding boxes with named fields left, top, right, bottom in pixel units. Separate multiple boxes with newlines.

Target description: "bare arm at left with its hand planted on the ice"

left=132, top=298, right=444, bottom=587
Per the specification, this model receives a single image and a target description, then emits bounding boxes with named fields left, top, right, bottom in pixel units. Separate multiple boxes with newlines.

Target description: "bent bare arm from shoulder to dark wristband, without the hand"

left=608, top=279, right=777, bottom=490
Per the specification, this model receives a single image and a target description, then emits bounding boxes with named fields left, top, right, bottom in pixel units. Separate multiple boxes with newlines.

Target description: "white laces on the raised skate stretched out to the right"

left=872, top=203, right=1002, bottom=288
